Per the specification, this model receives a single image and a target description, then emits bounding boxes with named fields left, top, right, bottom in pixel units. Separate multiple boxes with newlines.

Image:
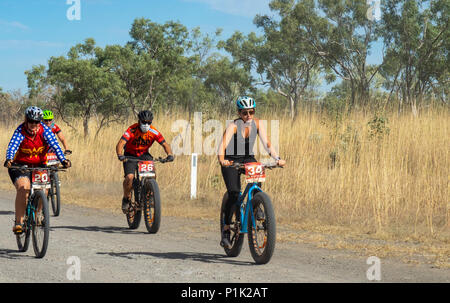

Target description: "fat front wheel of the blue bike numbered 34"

left=248, top=192, right=276, bottom=264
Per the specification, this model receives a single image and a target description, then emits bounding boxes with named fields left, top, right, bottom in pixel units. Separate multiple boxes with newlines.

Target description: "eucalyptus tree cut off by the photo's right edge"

left=381, top=0, right=450, bottom=115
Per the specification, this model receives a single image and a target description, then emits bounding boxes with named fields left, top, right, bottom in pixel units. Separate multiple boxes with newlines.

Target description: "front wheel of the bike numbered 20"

left=31, top=190, right=50, bottom=258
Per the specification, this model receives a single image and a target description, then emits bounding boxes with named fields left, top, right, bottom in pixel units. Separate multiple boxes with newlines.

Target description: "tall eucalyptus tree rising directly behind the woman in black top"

left=223, top=0, right=320, bottom=119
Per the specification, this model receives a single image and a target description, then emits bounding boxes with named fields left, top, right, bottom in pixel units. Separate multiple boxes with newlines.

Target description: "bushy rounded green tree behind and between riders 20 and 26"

left=45, top=38, right=126, bottom=138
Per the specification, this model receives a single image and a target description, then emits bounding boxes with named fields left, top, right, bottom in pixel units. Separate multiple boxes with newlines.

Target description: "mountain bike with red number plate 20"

left=11, top=166, right=62, bottom=258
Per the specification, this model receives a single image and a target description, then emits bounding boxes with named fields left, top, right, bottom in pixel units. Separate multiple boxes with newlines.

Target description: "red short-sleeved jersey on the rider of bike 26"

left=122, top=123, right=166, bottom=157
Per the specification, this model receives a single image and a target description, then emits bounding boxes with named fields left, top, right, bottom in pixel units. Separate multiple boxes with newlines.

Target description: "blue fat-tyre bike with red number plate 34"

left=220, top=162, right=280, bottom=264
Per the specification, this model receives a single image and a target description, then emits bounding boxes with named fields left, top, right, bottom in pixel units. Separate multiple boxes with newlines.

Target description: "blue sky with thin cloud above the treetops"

left=0, top=0, right=384, bottom=93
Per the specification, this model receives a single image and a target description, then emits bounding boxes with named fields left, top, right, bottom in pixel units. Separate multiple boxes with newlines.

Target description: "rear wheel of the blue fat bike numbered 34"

left=220, top=193, right=244, bottom=257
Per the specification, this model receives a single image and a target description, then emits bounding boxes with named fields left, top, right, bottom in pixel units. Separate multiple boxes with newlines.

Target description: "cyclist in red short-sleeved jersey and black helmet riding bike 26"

left=116, top=110, right=174, bottom=213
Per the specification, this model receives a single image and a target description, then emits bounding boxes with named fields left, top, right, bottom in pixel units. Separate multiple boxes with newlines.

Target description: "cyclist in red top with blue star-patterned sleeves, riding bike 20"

left=3, top=106, right=71, bottom=234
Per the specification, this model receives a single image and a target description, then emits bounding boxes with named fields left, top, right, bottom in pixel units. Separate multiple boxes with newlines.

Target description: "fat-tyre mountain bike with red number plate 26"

left=125, top=156, right=166, bottom=234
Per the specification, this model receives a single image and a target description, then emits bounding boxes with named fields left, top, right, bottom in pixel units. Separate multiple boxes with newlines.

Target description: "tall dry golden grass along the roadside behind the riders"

left=0, top=111, right=450, bottom=263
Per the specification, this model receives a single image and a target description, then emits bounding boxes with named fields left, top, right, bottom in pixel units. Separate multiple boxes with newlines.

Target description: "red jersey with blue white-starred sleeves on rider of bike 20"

left=6, top=123, right=66, bottom=165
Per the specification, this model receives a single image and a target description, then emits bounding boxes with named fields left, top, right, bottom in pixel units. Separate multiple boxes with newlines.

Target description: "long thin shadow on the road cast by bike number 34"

left=97, top=251, right=255, bottom=266
